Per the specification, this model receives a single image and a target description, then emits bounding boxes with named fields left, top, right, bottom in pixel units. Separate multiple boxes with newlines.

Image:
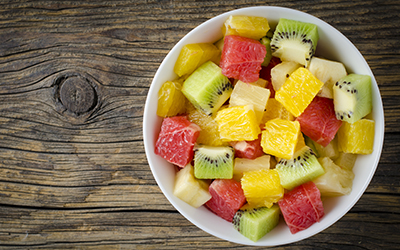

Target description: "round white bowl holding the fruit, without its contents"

left=143, top=6, right=384, bottom=246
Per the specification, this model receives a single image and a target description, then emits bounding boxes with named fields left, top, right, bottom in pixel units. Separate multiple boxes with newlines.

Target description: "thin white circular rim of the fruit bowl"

left=143, top=6, right=384, bottom=246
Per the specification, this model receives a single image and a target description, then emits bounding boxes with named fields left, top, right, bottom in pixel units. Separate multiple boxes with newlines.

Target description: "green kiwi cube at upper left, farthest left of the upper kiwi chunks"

left=182, top=61, right=233, bottom=116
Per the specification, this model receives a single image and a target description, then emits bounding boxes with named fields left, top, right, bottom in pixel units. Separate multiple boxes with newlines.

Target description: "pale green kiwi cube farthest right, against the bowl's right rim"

left=333, top=74, right=372, bottom=123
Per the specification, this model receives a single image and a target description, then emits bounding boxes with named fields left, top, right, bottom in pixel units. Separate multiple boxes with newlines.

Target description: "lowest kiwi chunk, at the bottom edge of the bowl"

left=232, top=204, right=280, bottom=242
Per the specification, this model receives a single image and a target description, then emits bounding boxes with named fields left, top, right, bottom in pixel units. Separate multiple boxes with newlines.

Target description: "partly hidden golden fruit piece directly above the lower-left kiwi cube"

left=186, top=103, right=228, bottom=146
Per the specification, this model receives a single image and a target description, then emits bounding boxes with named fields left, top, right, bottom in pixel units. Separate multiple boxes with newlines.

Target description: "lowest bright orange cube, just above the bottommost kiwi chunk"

left=241, top=169, right=284, bottom=208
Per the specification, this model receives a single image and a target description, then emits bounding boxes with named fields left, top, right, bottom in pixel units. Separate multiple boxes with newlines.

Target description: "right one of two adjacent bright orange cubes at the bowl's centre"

left=261, top=118, right=300, bottom=159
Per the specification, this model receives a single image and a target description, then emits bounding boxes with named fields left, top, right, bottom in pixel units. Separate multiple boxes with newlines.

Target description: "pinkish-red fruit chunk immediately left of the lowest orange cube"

left=206, top=179, right=246, bottom=222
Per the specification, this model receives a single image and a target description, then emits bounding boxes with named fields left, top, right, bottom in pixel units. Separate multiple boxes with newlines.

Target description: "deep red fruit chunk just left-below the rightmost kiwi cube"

left=296, top=96, right=342, bottom=147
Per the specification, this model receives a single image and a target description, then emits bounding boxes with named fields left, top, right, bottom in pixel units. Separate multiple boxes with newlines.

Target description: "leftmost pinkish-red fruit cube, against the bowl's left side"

left=155, top=116, right=200, bottom=168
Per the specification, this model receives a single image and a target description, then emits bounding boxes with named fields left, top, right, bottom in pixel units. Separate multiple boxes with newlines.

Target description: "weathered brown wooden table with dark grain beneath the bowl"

left=0, top=0, right=400, bottom=249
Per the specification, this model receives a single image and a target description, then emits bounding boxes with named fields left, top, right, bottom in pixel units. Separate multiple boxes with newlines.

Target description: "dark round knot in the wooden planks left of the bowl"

left=58, top=75, right=97, bottom=115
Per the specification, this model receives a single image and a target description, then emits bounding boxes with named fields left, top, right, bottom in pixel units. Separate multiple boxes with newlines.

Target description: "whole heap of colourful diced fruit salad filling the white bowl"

left=155, top=16, right=375, bottom=241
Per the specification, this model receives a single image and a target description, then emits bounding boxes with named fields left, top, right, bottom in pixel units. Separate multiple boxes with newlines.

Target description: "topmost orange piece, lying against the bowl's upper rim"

left=222, top=16, right=269, bottom=40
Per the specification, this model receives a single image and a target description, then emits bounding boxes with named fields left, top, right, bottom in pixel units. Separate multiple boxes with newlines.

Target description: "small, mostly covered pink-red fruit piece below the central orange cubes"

left=229, top=134, right=264, bottom=159
